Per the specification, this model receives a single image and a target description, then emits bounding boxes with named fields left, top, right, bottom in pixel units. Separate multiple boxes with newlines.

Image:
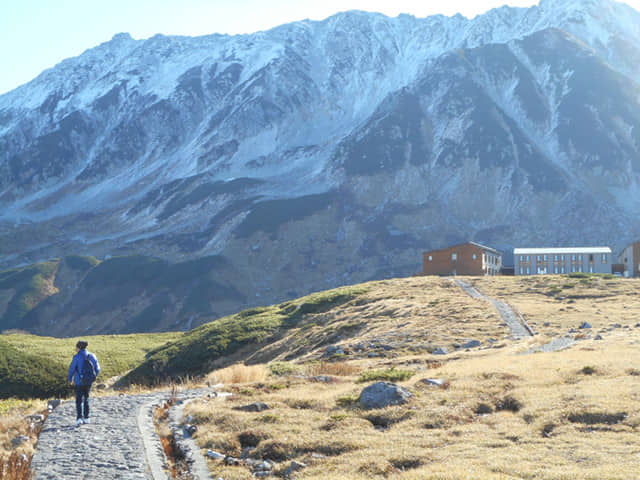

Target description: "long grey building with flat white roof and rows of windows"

left=513, top=247, right=613, bottom=275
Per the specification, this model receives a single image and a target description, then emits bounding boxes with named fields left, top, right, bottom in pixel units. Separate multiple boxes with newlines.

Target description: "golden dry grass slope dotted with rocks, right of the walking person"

left=181, top=276, right=640, bottom=480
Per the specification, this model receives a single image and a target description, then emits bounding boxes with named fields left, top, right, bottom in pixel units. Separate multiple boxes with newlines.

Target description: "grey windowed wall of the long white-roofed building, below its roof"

left=514, top=249, right=614, bottom=275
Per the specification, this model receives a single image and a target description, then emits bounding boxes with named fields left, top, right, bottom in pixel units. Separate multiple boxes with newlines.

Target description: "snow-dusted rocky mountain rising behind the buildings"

left=0, top=0, right=640, bottom=322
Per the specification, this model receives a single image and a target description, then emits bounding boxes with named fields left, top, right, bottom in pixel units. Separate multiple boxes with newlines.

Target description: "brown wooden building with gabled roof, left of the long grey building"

left=422, top=242, right=502, bottom=275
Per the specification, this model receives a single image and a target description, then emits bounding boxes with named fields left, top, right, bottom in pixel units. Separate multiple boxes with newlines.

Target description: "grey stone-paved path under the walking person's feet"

left=31, top=391, right=208, bottom=480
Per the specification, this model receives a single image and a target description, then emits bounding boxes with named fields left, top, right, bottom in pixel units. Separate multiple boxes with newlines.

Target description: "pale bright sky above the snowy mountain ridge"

left=0, top=0, right=640, bottom=94
